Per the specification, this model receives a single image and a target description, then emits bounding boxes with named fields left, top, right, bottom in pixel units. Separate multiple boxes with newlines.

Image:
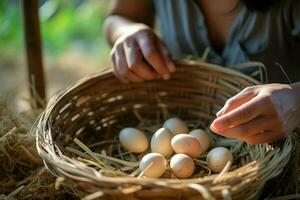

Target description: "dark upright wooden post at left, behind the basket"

left=21, top=0, right=45, bottom=107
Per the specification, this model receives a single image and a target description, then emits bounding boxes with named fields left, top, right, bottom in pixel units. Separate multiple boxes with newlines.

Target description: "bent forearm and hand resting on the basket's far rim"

left=104, top=0, right=175, bottom=83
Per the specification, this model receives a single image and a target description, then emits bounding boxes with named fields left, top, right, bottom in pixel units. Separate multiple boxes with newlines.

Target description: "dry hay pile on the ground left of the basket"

left=0, top=99, right=76, bottom=199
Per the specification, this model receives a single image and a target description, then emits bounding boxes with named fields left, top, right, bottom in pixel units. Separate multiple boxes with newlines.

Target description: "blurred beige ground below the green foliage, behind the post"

left=0, top=50, right=110, bottom=109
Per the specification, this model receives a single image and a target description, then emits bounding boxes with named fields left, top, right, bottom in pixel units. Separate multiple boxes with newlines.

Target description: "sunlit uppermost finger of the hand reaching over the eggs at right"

left=216, top=87, right=256, bottom=117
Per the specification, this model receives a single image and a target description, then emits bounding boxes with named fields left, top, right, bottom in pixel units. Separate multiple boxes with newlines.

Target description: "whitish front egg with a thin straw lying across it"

left=139, top=153, right=167, bottom=178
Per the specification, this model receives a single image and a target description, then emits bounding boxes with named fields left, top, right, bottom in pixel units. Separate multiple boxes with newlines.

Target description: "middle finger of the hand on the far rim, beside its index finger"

left=124, top=41, right=159, bottom=80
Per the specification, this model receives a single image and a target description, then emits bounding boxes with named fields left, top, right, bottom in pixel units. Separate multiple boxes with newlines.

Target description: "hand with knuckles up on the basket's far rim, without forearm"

left=111, top=24, right=175, bottom=83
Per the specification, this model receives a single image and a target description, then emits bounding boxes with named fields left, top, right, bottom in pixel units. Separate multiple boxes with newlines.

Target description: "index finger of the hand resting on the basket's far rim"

left=137, top=32, right=170, bottom=79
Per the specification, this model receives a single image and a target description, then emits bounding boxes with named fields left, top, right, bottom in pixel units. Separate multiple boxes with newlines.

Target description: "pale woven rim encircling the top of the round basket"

left=31, top=60, right=292, bottom=199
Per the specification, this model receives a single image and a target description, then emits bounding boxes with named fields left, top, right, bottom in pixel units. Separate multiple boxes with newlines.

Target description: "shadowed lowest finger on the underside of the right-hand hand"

left=216, top=117, right=280, bottom=139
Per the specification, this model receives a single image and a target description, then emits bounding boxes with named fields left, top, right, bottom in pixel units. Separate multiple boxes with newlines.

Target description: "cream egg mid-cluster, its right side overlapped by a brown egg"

left=150, top=128, right=173, bottom=157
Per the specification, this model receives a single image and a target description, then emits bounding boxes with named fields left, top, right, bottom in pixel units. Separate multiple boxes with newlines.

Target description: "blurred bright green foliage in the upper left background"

left=0, top=0, right=109, bottom=56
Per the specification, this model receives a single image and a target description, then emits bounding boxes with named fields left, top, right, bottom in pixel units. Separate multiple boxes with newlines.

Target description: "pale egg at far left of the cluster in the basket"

left=119, top=128, right=149, bottom=153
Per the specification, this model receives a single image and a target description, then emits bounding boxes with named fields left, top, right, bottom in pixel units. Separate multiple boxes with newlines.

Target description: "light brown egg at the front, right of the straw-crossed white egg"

left=170, top=154, right=195, bottom=178
